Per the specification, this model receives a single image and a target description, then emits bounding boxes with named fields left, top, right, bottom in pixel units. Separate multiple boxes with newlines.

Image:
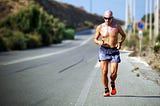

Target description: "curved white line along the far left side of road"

left=2, top=36, right=93, bottom=65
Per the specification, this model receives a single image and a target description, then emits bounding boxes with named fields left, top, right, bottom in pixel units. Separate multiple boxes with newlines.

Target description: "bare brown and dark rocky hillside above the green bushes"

left=0, top=0, right=124, bottom=30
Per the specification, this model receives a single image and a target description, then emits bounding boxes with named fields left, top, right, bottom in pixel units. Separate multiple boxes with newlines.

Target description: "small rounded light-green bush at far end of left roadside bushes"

left=64, top=29, right=75, bottom=39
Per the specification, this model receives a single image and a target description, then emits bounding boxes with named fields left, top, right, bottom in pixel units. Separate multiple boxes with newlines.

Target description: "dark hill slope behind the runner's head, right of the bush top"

left=35, top=0, right=124, bottom=29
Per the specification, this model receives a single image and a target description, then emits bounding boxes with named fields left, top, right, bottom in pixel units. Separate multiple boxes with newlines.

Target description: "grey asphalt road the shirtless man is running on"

left=0, top=34, right=160, bottom=106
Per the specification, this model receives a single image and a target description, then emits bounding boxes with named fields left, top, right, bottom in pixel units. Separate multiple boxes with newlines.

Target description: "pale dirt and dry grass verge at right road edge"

left=129, top=51, right=160, bottom=85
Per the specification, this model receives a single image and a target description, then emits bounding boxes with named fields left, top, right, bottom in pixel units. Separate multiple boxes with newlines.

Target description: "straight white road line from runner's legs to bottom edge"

left=75, top=62, right=99, bottom=106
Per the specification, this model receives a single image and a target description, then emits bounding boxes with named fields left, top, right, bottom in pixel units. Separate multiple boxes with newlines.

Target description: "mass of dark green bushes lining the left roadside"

left=0, top=3, right=75, bottom=51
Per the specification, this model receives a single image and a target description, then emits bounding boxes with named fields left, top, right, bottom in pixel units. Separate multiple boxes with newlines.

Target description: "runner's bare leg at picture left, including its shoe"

left=100, top=61, right=109, bottom=96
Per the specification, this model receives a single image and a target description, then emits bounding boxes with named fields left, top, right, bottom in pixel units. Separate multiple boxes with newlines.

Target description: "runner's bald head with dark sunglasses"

left=103, top=10, right=113, bottom=25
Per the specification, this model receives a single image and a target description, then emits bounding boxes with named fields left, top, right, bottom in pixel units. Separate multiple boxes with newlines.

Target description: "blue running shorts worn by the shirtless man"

left=98, top=46, right=121, bottom=63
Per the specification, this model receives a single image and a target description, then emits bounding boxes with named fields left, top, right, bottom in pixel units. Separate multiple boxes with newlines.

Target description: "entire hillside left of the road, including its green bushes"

left=0, top=0, right=125, bottom=51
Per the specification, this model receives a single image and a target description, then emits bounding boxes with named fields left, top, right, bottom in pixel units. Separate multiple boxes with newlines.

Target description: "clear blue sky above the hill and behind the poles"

left=56, top=0, right=160, bottom=21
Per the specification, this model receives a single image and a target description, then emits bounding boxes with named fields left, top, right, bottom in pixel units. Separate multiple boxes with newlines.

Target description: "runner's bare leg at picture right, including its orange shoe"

left=110, top=63, right=118, bottom=95
